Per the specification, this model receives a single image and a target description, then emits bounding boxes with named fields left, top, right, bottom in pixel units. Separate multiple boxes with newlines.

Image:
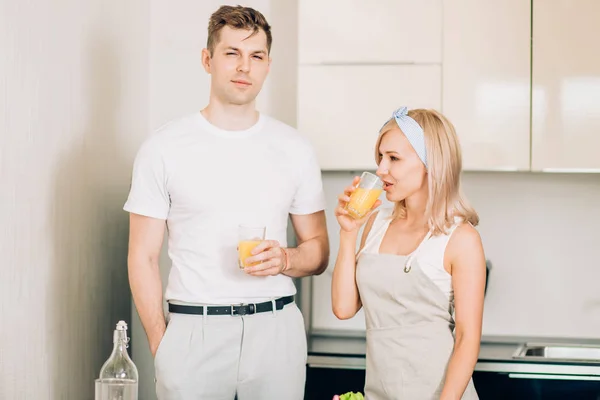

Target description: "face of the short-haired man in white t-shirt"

left=202, top=26, right=271, bottom=105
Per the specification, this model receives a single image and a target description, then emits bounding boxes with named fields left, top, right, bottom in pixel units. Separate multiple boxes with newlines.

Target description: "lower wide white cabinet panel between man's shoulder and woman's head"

left=297, top=65, right=441, bottom=170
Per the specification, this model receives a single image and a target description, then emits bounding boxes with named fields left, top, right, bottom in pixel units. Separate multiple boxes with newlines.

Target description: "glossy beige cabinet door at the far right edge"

left=532, top=0, right=600, bottom=172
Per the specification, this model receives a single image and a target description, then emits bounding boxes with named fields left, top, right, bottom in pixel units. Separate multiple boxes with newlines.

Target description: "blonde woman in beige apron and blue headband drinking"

left=332, top=107, right=485, bottom=400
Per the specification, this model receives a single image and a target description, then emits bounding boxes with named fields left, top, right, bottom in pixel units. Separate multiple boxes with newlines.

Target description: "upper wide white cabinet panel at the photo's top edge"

left=298, top=0, right=442, bottom=65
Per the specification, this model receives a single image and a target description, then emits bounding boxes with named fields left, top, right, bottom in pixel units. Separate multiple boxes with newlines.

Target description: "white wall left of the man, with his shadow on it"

left=0, top=0, right=148, bottom=400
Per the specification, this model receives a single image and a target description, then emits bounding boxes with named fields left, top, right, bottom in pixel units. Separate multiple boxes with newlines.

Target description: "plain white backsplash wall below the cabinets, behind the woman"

left=312, top=172, right=600, bottom=338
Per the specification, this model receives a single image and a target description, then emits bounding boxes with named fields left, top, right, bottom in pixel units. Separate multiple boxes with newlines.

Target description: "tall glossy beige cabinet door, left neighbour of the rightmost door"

left=442, top=0, right=528, bottom=170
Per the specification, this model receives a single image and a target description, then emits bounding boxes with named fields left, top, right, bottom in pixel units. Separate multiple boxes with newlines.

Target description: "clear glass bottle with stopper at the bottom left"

left=96, top=321, right=138, bottom=400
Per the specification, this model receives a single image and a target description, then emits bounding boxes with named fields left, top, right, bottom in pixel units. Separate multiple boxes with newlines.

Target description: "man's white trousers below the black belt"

left=154, top=303, right=307, bottom=400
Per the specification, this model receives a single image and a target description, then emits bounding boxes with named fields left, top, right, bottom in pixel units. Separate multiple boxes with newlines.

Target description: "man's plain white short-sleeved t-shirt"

left=124, top=112, right=325, bottom=304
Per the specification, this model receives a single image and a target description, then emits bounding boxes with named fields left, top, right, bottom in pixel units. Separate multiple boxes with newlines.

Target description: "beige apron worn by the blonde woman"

left=356, top=231, right=478, bottom=400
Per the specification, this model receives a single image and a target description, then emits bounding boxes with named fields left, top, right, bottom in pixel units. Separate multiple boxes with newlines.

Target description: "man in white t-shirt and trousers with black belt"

left=124, top=6, right=329, bottom=400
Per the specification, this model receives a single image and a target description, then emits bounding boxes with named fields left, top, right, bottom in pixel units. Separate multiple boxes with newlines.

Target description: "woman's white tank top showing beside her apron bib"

left=361, top=207, right=461, bottom=302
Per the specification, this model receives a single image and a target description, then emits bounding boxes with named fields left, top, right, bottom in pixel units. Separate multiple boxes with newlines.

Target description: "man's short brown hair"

left=206, top=6, right=273, bottom=56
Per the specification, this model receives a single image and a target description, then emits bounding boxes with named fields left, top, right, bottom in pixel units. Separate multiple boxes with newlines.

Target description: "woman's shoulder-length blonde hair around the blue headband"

left=375, top=109, right=479, bottom=235
